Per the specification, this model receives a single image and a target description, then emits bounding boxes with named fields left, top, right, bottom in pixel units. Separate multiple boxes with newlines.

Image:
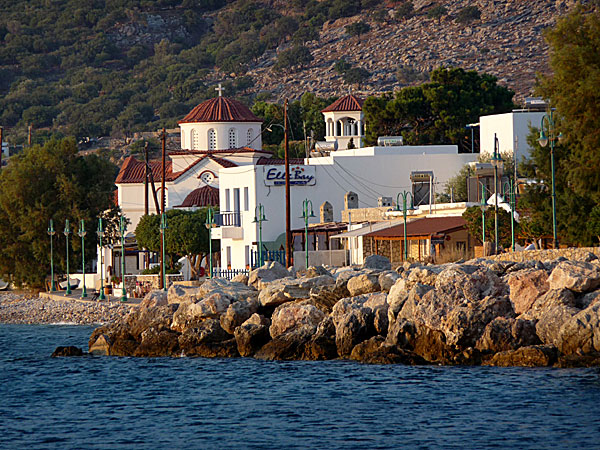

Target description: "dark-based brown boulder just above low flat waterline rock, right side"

left=475, top=317, right=541, bottom=353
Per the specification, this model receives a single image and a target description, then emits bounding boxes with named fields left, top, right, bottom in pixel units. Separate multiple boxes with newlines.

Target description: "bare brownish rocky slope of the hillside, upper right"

left=250, top=0, right=581, bottom=101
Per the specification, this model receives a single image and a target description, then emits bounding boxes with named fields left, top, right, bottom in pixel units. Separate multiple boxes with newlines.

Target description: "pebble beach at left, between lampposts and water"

left=0, top=292, right=132, bottom=325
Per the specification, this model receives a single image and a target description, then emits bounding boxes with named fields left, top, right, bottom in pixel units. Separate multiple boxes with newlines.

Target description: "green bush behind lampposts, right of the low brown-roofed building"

left=463, top=206, right=520, bottom=249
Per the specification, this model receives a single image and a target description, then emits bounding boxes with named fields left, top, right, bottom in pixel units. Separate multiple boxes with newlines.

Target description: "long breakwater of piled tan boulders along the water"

left=89, top=253, right=600, bottom=367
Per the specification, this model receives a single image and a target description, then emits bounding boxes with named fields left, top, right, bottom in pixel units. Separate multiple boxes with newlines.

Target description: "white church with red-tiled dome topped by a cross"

left=110, top=94, right=272, bottom=274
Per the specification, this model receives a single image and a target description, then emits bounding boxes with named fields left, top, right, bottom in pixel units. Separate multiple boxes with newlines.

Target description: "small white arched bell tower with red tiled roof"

left=321, top=95, right=365, bottom=150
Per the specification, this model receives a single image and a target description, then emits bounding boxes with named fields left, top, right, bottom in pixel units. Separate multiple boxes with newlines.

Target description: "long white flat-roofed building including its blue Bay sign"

left=213, top=145, right=476, bottom=269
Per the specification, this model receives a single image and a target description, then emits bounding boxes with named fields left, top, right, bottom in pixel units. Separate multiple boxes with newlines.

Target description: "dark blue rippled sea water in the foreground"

left=0, top=325, right=600, bottom=449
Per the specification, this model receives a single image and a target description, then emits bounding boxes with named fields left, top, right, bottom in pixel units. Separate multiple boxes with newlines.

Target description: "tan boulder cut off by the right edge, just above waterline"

left=557, top=302, right=600, bottom=355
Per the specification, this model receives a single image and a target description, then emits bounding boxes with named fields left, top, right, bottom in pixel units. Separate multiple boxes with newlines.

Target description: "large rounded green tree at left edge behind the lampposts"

left=0, top=139, right=118, bottom=287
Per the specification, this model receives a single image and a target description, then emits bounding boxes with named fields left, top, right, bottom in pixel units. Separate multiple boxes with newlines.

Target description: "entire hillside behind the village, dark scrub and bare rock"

left=0, top=0, right=578, bottom=143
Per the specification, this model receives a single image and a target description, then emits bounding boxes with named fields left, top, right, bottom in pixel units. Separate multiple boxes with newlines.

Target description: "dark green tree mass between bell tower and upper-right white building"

left=363, top=68, right=514, bottom=150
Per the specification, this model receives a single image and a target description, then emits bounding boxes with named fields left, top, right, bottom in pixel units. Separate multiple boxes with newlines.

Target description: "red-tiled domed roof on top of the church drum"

left=179, top=96, right=262, bottom=124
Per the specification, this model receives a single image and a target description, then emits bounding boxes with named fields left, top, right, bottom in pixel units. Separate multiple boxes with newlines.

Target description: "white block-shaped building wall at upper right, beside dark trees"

left=479, top=111, right=545, bottom=161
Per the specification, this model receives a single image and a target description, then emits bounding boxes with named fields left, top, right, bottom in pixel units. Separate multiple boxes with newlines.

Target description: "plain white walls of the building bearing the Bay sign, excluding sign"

left=215, top=146, right=477, bottom=269
